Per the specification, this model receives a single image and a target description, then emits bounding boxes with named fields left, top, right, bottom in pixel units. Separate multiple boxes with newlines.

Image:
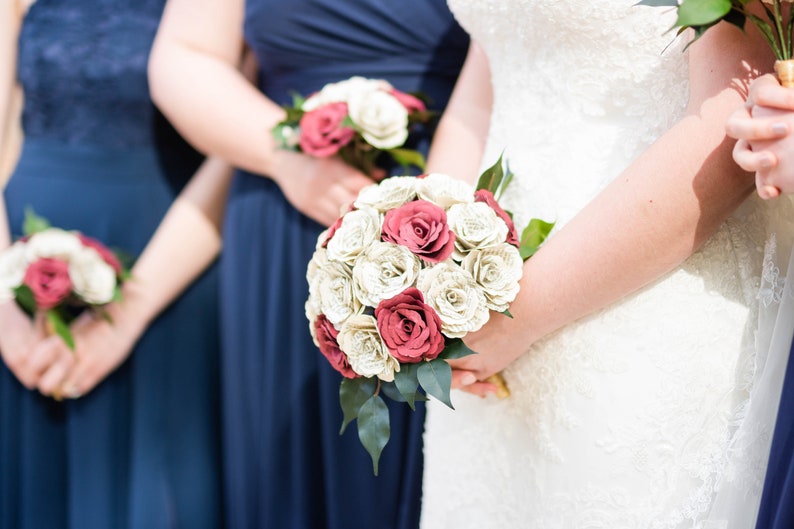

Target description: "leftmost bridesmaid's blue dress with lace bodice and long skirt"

left=0, top=0, right=221, bottom=529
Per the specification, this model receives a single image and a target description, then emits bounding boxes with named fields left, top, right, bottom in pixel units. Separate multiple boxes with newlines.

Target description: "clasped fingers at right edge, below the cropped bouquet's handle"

left=726, top=75, right=794, bottom=199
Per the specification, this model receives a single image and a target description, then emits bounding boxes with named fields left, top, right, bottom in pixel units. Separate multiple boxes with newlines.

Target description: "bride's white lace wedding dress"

left=422, top=0, right=794, bottom=529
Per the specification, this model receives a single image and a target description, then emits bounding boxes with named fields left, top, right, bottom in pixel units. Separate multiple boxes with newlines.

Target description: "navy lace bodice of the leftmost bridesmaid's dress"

left=18, top=0, right=165, bottom=147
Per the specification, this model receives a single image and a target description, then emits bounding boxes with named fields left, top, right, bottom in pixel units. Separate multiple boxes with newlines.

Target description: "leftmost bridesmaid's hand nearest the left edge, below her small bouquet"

left=0, top=301, right=51, bottom=389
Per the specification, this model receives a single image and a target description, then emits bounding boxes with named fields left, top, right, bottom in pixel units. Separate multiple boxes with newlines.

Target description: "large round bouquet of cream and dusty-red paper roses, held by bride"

left=306, top=158, right=553, bottom=475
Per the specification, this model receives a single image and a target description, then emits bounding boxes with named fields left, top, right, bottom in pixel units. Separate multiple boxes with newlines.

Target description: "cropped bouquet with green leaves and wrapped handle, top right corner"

left=638, top=0, right=794, bottom=83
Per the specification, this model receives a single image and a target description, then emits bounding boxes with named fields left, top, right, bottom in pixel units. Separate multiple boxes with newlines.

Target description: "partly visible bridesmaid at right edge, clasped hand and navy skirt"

left=727, top=75, right=794, bottom=529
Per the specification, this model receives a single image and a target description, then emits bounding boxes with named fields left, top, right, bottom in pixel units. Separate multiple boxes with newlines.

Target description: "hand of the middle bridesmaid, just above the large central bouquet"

left=271, top=151, right=382, bottom=226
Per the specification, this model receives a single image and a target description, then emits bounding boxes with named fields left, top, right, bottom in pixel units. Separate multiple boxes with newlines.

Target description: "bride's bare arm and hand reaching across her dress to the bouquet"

left=457, top=20, right=772, bottom=384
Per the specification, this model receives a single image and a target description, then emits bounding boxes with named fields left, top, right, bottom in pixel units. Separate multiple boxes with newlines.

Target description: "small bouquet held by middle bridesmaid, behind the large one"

left=273, top=77, right=433, bottom=174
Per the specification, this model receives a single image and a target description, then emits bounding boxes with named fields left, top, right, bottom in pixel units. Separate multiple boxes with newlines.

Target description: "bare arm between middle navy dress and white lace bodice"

left=427, top=41, right=493, bottom=184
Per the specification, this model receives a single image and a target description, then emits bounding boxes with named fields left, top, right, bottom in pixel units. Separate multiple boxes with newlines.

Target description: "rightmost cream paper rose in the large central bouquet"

left=460, top=242, right=524, bottom=312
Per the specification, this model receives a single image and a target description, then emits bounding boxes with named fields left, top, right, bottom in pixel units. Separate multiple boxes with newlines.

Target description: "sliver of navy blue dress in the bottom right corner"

left=756, top=334, right=794, bottom=529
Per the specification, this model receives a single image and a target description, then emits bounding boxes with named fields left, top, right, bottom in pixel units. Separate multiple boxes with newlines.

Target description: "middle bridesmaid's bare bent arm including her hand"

left=149, top=0, right=372, bottom=225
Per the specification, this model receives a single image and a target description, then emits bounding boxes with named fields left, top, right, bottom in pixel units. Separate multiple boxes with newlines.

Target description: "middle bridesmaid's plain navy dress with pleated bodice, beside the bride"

left=221, top=0, right=468, bottom=529
